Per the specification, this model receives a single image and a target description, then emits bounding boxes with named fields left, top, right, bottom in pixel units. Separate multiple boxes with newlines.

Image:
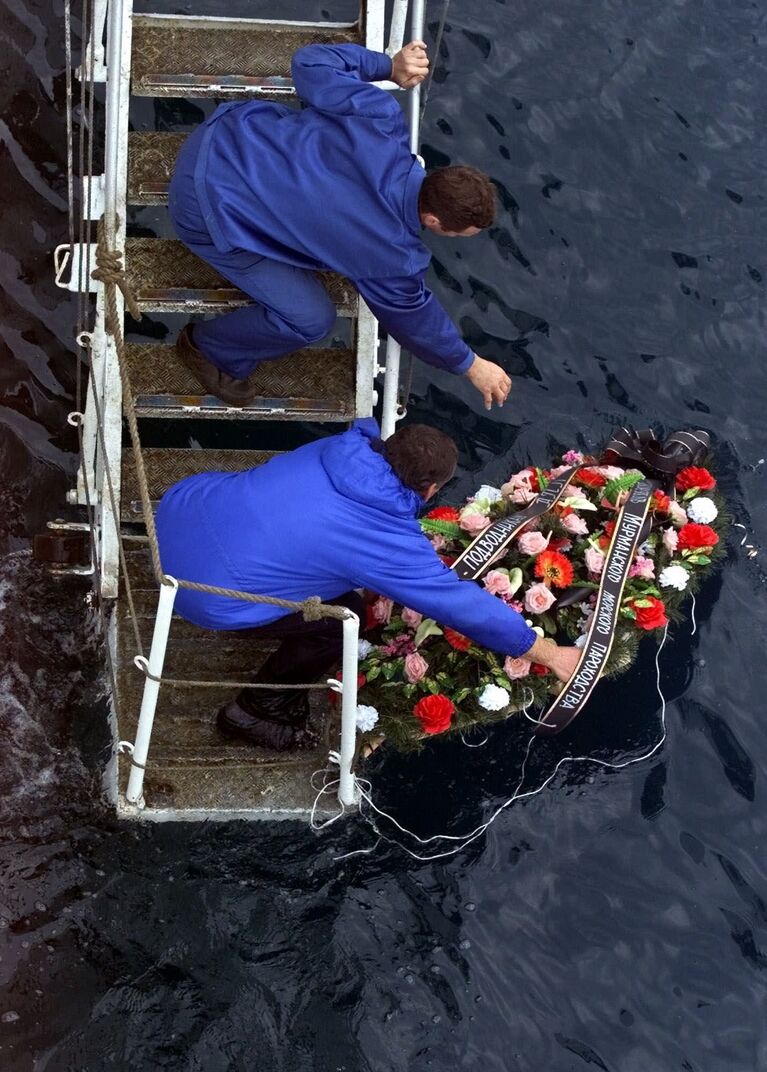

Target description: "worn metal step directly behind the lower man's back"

left=120, top=447, right=279, bottom=521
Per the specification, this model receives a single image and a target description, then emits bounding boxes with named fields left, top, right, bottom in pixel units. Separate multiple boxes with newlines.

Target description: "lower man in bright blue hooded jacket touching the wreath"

left=157, top=418, right=579, bottom=749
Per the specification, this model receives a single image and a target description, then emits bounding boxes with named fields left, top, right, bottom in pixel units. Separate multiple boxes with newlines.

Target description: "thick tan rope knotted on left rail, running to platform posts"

left=91, top=217, right=349, bottom=622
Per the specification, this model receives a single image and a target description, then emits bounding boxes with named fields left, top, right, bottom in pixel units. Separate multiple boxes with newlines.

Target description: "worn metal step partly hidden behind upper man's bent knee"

left=126, top=238, right=357, bottom=316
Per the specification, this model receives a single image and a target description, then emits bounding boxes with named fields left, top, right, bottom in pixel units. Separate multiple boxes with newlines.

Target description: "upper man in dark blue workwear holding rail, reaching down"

left=169, top=42, right=511, bottom=408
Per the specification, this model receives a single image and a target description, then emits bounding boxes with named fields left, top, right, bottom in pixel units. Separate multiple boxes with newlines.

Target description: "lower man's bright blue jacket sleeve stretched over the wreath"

left=355, top=518, right=537, bottom=656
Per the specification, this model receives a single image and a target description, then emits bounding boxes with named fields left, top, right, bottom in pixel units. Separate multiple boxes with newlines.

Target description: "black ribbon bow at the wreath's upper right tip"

left=601, top=428, right=711, bottom=494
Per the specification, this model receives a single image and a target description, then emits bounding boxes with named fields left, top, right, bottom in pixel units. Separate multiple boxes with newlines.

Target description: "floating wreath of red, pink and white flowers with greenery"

left=358, top=450, right=724, bottom=750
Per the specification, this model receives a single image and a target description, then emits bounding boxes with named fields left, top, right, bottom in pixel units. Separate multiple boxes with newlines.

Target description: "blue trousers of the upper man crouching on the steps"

left=169, top=130, right=336, bottom=379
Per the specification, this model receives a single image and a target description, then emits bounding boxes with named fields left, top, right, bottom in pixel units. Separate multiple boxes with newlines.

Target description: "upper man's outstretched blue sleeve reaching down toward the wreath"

left=354, top=276, right=474, bottom=375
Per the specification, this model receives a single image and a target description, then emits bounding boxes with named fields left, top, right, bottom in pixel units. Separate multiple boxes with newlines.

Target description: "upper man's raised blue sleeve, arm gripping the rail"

left=291, top=45, right=392, bottom=121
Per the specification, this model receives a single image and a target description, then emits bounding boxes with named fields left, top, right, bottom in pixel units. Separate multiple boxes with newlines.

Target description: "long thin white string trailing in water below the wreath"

left=332, top=625, right=668, bottom=863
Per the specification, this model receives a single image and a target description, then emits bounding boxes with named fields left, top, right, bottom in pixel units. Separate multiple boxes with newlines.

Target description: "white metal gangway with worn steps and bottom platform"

left=55, top=0, right=425, bottom=819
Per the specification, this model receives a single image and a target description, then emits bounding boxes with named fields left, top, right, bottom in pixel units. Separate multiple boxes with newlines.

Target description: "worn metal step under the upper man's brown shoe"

left=127, top=343, right=356, bottom=421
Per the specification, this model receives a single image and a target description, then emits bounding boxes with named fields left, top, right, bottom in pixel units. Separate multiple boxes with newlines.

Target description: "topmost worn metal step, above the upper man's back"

left=131, top=15, right=364, bottom=99
